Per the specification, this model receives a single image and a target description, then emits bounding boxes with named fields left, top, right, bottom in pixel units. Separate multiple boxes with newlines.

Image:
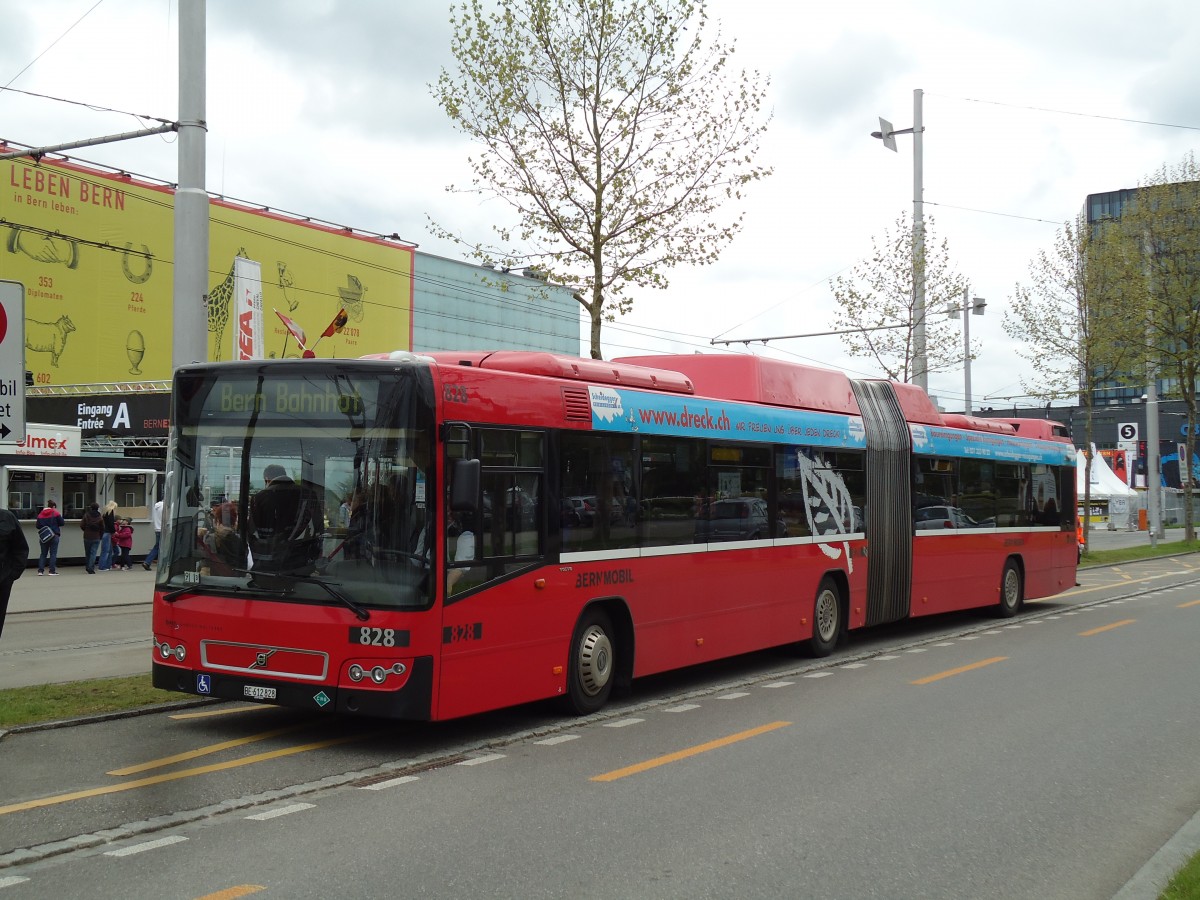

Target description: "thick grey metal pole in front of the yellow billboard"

left=170, top=0, right=209, bottom=368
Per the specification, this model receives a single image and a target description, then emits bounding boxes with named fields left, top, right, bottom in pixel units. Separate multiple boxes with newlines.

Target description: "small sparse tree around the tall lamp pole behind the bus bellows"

left=832, top=212, right=960, bottom=382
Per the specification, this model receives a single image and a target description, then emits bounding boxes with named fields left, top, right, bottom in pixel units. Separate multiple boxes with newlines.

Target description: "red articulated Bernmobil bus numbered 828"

left=154, top=352, right=1076, bottom=720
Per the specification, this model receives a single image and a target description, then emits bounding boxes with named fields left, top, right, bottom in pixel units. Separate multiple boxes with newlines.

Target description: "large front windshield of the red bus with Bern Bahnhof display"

left=160, top=360, right=437, bottom=612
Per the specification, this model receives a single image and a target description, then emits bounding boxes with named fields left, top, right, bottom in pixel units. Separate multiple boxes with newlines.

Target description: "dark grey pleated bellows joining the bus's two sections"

left=852, top=380, right=912, bottom=625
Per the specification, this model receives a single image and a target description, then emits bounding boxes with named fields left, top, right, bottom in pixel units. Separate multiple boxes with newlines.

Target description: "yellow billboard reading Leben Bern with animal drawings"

left=0, top=151, right=413, bottom=385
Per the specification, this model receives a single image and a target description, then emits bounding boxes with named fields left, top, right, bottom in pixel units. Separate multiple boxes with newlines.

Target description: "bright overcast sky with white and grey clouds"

left=0, top=0, right=1200, bottom=409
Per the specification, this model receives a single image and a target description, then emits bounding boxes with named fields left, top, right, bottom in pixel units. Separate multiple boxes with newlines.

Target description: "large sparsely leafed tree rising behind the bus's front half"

left=432, top=0, right=772, bottom=359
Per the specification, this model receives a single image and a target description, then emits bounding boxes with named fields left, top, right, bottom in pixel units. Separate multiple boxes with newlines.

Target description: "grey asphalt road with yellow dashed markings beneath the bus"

left=0, top=535, right=1200, bottom=900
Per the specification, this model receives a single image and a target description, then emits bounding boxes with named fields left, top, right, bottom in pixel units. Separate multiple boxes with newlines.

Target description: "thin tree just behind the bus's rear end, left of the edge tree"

left=1003, top=217, right=1144, bottom=545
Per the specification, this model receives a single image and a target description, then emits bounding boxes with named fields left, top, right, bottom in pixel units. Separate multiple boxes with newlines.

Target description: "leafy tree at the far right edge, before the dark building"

left=1120, top=154, right=1200, bottom=540
